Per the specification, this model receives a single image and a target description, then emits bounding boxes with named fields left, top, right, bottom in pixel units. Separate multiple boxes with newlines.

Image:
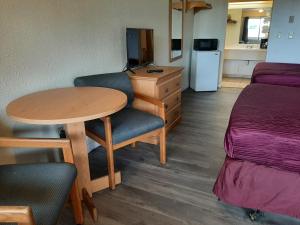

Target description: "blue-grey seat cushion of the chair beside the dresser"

left=86, top=108, right=164, bottom=144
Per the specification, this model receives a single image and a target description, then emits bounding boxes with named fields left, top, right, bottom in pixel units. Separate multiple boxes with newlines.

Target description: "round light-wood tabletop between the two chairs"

left=6, top=87, right=127, bottom=125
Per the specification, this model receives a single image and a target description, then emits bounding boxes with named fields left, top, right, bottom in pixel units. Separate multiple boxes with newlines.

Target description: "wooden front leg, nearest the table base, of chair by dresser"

left=103, top=117, right=116, bottom=190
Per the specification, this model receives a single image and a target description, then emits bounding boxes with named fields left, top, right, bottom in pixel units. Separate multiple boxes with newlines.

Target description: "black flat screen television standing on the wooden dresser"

left=126, top=28, right=154, bottom=68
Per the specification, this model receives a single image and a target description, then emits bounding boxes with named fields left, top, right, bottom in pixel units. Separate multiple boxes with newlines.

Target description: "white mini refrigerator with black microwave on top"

left=190, top=51, right=221, bottom=91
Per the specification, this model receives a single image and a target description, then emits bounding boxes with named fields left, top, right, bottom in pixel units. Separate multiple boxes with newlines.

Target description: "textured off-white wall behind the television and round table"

left=0, top=0, right=193, bottom=163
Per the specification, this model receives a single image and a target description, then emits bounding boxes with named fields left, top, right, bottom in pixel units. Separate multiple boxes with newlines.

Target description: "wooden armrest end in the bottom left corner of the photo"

left=0, top=206, right=35, bottom=225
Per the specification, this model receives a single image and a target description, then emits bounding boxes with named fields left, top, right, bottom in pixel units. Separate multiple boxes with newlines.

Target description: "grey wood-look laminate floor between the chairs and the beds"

left=60, top=88, right=300, bottom=225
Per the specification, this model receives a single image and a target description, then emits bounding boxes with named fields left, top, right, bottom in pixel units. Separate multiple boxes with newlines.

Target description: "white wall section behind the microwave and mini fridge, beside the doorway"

left=194, top=0, right=228, bottom=85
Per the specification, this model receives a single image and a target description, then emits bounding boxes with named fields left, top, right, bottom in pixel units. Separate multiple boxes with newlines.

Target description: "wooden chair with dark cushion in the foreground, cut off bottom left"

left=0, top=138, right=83, bottom=225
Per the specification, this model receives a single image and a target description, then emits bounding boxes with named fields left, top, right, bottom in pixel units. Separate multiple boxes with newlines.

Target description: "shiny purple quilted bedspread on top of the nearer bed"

left=225, top=84, right=300, bottom=172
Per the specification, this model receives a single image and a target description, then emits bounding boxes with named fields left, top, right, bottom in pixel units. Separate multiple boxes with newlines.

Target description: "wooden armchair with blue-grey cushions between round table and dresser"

left=74, top=72, right=166, bottom=189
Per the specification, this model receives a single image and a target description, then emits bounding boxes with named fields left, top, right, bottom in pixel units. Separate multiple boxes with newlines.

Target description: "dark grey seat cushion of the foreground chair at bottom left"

left=0, top=163, right=76, bottom=225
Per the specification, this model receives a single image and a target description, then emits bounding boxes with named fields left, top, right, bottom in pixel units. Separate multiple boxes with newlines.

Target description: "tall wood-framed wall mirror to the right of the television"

left=169, top=0, right=184, bottom=62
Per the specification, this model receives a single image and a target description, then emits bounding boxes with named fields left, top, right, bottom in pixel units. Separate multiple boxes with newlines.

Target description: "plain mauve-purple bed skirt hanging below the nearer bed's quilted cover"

left=213, top=158, right=300, bottom=219
